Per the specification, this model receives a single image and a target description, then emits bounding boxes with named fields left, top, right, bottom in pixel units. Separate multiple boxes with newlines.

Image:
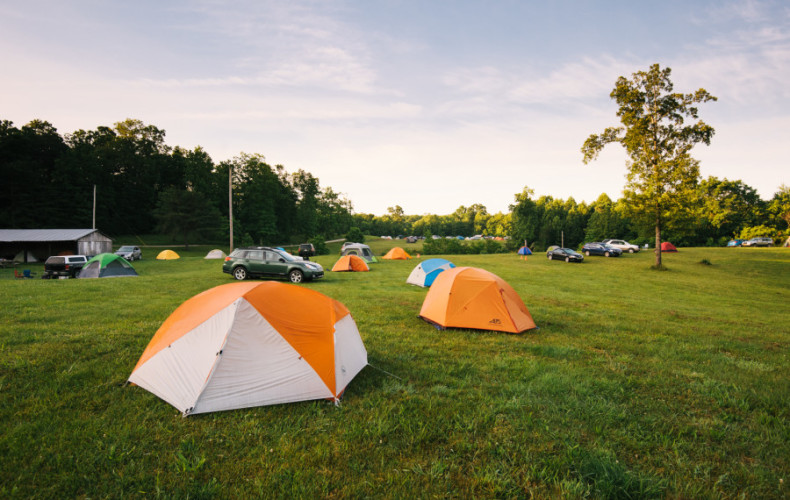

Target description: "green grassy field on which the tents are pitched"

left=0, top=241, right=790, bottom=498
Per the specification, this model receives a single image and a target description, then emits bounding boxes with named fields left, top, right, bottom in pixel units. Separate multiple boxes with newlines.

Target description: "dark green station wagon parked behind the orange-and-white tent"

left=222, top=247, right=324, bottom=283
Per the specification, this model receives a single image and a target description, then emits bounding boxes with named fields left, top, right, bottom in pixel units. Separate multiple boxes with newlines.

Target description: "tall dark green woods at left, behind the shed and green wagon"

left=0, top=119, right=352, bottom=248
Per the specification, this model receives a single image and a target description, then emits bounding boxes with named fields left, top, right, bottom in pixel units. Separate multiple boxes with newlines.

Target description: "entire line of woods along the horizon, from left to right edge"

left=0, top=119, right=790, bottom=250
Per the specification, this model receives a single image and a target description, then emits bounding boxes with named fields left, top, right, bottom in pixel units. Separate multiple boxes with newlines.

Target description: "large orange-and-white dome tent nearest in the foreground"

left=129, top=281, right=367, bottom=416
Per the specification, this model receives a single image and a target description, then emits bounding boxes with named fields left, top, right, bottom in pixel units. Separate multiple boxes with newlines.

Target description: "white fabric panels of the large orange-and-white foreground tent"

left=129, top=297, right=367, bottom=415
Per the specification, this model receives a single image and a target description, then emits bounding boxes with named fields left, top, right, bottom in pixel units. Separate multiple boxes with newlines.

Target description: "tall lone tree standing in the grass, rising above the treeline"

left=582, top=64, right=716, bottom=268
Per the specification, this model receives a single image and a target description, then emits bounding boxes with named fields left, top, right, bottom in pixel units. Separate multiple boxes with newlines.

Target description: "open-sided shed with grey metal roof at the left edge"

left=0, top=229, right=112, bottom=262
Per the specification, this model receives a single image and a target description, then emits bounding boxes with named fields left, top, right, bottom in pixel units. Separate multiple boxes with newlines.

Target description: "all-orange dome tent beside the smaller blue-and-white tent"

left=420, top=267, right=537, bottom=333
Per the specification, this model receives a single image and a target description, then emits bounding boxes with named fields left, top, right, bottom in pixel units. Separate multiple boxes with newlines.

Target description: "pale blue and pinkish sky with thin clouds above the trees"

left=0, top=0, right=790, bottom=215
